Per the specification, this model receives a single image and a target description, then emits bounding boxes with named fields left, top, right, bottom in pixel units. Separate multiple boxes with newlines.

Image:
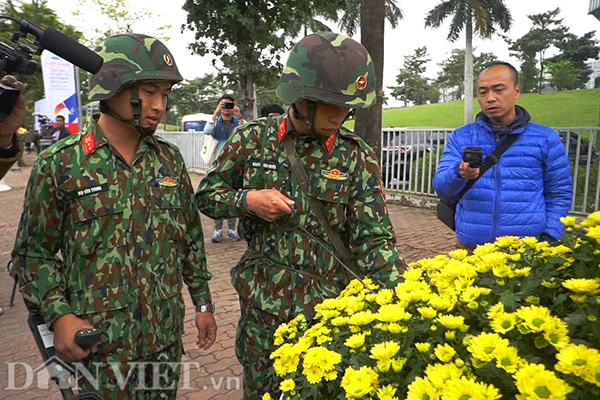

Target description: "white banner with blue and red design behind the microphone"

left=41, top=50, right=79, bottom=133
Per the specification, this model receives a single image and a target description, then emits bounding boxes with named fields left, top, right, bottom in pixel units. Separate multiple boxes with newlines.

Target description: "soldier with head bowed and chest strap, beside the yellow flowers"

left=196, top=33, right=404, bottom=399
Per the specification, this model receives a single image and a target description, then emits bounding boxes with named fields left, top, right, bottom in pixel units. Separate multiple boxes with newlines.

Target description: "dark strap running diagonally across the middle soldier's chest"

left=282, top=133, right=355, bottom=267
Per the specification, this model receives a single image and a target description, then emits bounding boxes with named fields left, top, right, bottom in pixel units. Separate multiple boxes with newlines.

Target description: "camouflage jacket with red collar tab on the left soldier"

left=13, top=118, right=211, bottom=360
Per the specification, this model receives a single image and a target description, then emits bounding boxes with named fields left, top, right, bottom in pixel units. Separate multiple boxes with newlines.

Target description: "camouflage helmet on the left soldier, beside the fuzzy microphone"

left=90, top=33, right=183, bottom=100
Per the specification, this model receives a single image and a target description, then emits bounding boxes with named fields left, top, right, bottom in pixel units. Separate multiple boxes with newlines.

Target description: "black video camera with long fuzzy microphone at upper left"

left=0, top=15, right=104, bottom=122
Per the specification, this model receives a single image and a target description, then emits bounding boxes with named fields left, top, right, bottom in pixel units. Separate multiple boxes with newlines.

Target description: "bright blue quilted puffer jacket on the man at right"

left=433, top=108, right=572, bottom=248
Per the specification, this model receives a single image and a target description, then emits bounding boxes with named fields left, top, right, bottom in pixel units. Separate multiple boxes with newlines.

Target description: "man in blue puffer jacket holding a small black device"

left=433, top=63, right=572, bottom=249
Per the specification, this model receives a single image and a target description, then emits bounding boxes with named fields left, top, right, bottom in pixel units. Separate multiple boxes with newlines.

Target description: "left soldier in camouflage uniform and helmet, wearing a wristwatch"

left=13, top=34, right=216, bottom=399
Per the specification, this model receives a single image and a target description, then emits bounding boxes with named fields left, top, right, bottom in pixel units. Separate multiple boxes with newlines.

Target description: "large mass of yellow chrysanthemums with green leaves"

left=271, top=213, right=600, bottom=400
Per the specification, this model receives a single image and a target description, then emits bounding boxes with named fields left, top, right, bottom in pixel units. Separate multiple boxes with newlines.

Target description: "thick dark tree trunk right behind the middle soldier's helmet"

left=354, top=0, right=385, bottom=157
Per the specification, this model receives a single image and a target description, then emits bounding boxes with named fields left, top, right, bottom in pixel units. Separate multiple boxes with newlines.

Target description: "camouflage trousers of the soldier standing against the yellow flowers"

left=235, top=300, right=285, bottom=400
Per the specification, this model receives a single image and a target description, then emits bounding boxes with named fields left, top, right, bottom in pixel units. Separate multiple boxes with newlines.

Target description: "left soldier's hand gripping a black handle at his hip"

left=52, top=314, right=97, bottom=362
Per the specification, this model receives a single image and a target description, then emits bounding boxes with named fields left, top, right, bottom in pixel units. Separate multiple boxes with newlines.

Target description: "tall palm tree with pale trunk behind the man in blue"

left=425, top=0, right=512, bottom=124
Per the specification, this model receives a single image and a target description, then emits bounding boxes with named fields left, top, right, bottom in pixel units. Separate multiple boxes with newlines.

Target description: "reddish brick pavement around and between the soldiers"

left=0, top=155, right=455, bottom=400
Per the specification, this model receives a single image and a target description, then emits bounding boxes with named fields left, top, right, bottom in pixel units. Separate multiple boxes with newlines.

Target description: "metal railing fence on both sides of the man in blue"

left=381, top=127, right=600, bottom=215
